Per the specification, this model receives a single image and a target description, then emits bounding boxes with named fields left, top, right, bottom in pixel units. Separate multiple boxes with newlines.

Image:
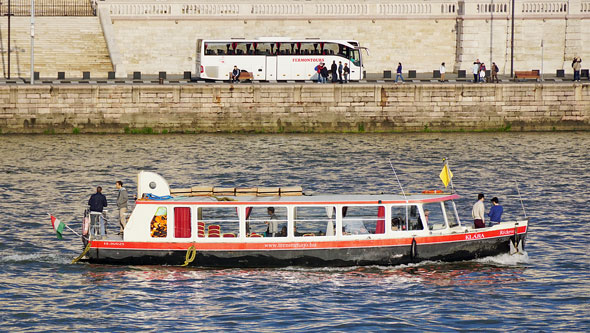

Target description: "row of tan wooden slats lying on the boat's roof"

left=170, top=186, right=303, bottom=197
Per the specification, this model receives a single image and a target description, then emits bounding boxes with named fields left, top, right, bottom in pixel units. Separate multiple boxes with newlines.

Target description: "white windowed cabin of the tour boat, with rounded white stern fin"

left=123, top=171, right=460, bottom=241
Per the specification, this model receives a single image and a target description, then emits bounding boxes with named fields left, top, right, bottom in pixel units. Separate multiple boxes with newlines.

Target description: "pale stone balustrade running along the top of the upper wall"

left=98, top=0, right=590, bottom=20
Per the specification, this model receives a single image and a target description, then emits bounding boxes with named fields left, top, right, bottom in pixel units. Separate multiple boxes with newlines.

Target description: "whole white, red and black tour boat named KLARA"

left=67, top=171, right=528, bottom=267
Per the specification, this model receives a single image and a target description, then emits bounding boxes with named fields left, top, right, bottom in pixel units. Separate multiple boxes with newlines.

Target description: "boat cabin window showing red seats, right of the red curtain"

left=197, top=207, right=240, bottom=238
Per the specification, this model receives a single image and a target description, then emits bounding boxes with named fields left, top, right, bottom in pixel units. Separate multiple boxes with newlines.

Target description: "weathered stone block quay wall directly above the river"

left=0, top=84, right=590, bottom=133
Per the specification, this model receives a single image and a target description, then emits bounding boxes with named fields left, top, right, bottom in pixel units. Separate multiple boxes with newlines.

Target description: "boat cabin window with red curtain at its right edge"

left=342, top=206, right=385, bottom=235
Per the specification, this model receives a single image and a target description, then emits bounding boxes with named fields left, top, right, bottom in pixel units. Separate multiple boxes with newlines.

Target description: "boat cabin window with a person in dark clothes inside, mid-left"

left=246, top=207, right=287, bottom=237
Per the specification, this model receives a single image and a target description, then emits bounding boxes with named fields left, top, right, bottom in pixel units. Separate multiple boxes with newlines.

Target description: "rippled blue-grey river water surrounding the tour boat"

left=0, top=132, right=590, bottom=332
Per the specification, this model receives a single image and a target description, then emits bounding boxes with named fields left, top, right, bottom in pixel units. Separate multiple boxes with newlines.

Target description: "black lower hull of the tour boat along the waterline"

left=87, top=229, right=526, bottom=267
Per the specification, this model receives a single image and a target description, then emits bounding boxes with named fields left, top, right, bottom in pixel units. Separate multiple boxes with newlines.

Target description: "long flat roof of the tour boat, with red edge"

left=137, top=193, right=459, bottom=205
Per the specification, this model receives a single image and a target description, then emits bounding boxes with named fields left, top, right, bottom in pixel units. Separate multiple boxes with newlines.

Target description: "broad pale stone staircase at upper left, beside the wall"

left=0, top=17, right=113, bottom=79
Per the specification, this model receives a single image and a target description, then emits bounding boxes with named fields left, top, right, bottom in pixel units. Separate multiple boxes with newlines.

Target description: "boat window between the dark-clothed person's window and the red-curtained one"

left=294, top=206, right=336, bottom=237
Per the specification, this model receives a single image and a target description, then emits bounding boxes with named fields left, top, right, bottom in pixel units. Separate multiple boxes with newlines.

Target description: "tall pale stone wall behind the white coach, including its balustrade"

left=98, top=0, right=590, bottom=74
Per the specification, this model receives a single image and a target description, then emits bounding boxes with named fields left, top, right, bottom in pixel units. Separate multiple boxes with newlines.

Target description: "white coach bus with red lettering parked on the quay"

left=196, top=38, right=366, bottom=81
